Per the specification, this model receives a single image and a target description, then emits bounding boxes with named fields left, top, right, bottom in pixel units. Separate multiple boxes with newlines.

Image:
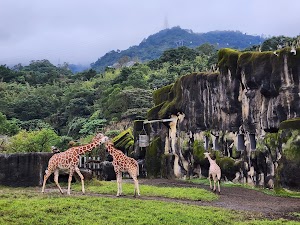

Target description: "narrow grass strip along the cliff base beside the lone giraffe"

left=187, top=178, right=300, bottom=198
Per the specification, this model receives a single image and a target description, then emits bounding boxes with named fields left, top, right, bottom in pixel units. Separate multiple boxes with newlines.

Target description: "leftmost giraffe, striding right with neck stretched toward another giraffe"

left=42, top=133, right=105, bottom=195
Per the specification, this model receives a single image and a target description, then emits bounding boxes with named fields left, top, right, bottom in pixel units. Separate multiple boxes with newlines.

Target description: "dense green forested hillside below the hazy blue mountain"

left=0, top=37, right=296, bottom=152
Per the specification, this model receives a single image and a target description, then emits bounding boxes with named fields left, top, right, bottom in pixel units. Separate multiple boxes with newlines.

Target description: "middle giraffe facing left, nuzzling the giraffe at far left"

left=104, top=137, right=140, bottom=197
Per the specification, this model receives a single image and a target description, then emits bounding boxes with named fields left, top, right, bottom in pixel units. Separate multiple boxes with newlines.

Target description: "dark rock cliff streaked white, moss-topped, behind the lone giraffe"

left=148, top=49, right=300, bottom=190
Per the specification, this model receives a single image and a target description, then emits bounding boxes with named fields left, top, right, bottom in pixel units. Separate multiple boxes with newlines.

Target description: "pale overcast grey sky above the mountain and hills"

left=0, top=0, right=300, bottom=66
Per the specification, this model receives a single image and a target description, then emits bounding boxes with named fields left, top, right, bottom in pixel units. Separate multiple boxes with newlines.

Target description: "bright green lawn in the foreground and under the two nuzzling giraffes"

left=0, top=181, right=300, bottom=225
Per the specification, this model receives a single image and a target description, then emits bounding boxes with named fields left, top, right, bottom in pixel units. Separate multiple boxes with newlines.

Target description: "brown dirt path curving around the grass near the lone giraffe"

left=48, top=179, right=300, bottom=221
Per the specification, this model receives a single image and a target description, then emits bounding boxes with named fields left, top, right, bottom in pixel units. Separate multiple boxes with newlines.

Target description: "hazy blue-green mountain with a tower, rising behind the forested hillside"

left=91, top=27, right=264, bottom=71
